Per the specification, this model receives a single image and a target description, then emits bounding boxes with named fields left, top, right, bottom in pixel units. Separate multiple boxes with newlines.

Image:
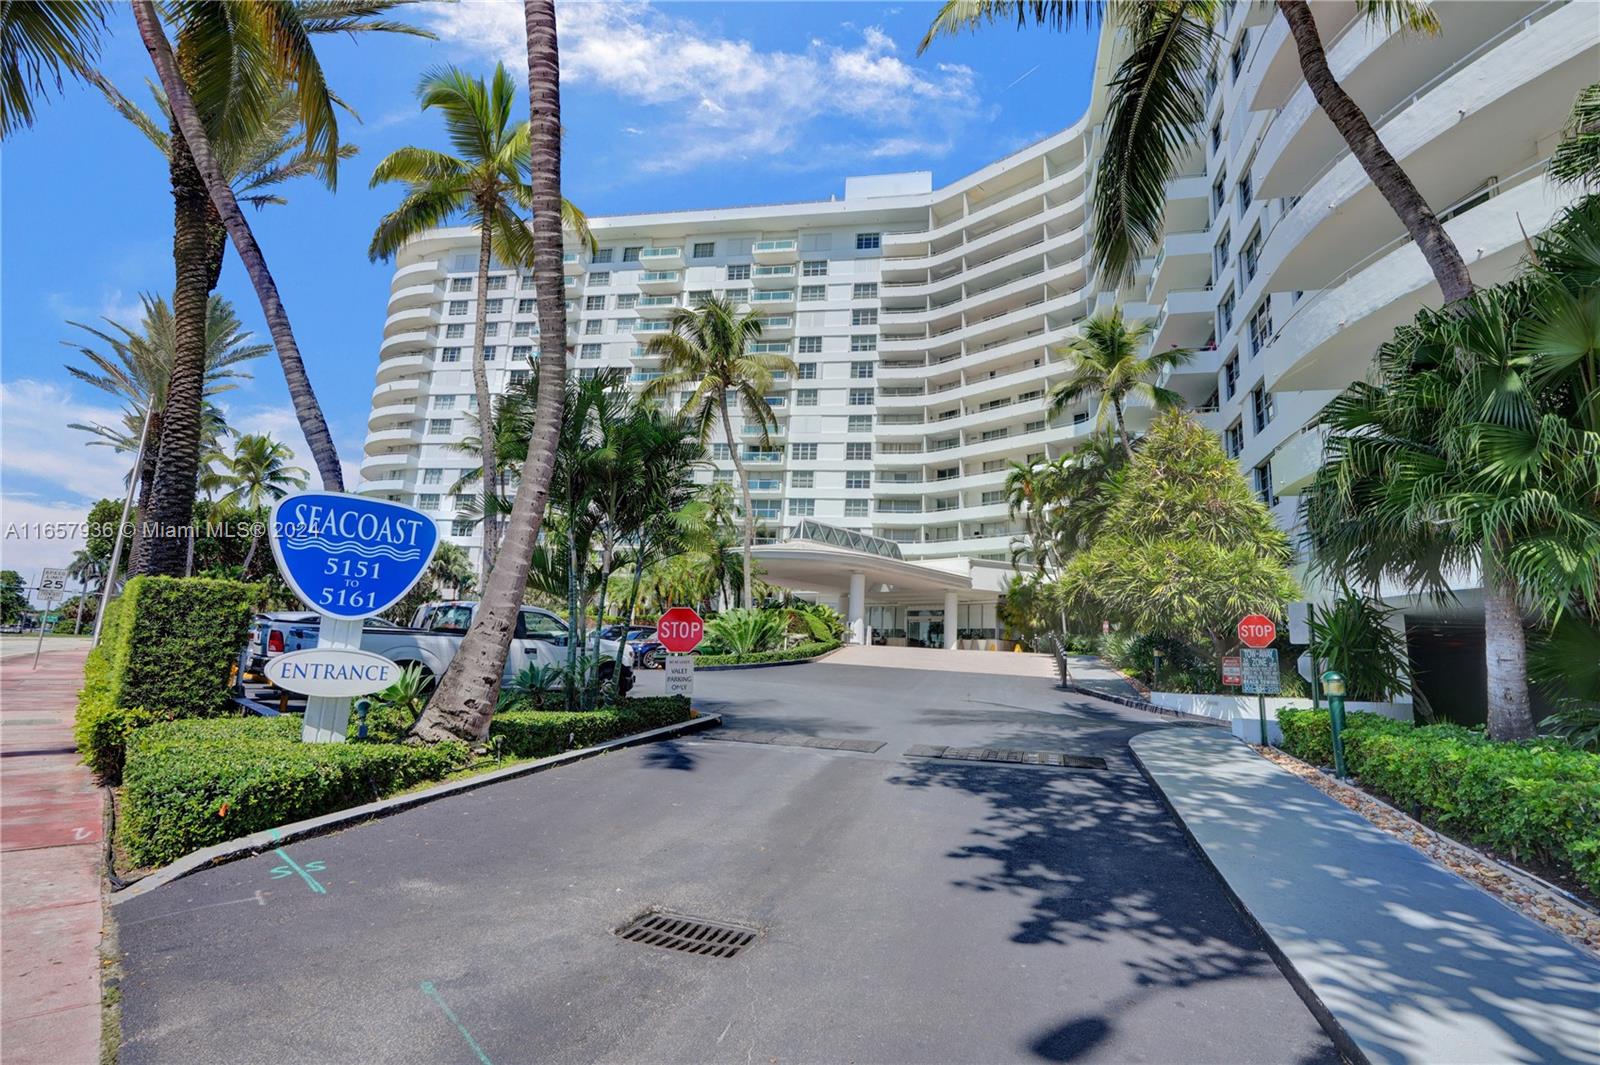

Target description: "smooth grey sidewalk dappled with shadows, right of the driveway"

left=1130, top=729, right=1600, bottom=1065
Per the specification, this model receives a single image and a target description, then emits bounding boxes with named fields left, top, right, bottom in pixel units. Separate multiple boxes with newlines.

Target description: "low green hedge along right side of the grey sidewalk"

left=1278, top=710, right=1600, bottom=892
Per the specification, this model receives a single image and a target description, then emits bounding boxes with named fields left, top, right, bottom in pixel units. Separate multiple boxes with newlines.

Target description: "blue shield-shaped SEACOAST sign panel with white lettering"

left=267, top=493, right=438, bottom=620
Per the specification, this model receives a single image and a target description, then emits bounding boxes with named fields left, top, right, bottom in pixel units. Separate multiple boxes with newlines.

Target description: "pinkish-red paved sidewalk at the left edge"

left=0, top=640, right=102, bottom=1065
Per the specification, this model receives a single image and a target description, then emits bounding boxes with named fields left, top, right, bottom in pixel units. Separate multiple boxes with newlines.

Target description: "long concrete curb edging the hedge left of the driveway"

left=110, top=713, right=722, bottom=907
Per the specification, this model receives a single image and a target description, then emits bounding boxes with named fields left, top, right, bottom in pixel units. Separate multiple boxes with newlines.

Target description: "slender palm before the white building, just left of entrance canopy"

left=645, top=296, right=795, bottom=606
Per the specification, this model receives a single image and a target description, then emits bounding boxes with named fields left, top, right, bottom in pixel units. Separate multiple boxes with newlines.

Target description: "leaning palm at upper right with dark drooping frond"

left=917, top=0, right=1472, bottom=302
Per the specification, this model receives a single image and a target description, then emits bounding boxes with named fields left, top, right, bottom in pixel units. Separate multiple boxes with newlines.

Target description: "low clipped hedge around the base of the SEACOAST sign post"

left=120, top=715, right=467, bottom=865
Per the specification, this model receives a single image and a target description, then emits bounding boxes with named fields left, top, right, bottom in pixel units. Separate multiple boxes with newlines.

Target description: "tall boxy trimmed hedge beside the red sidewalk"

left=74, top=577, right=261, bottom=784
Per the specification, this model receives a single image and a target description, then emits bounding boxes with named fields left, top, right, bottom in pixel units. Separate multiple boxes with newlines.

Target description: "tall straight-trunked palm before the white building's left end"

left=366, top=64, right=594, bottom=580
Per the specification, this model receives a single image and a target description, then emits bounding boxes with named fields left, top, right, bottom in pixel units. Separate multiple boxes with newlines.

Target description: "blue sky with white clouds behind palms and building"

left=0, top=0, right=1094, bottom=579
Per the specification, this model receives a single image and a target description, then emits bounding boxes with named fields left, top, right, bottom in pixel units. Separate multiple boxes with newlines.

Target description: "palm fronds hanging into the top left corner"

left=0, top=0, right=115, bottom=139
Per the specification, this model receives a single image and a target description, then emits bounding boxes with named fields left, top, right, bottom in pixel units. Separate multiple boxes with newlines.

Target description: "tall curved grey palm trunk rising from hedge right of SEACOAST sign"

left=411, top=0, right=566, bottom=742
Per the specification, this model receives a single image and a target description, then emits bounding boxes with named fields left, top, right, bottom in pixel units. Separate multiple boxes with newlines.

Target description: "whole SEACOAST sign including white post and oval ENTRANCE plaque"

left=267, top=493, right=438, bottom=744
